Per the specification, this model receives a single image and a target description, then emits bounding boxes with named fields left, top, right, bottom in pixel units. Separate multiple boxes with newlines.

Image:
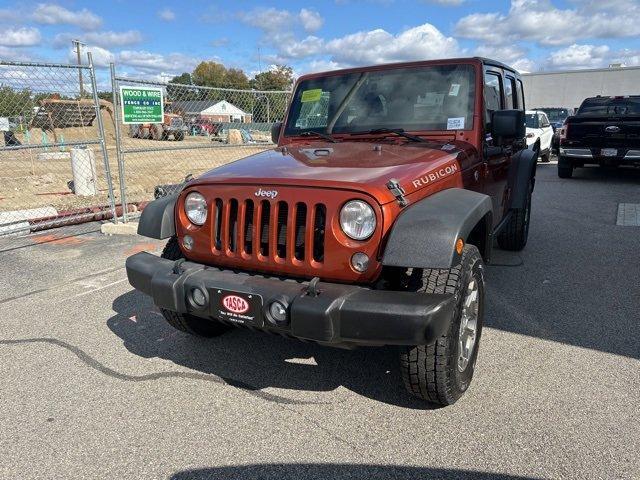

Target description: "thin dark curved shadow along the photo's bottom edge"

left=170, top=463, right=533, bottom=480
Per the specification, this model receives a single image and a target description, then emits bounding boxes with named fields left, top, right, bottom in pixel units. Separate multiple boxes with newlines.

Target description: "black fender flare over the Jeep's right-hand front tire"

left=382, top=188, right=493, bottom=268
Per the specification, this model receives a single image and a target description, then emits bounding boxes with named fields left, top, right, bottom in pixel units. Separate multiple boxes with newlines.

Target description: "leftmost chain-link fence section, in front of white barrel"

left=0, top=55, right=117, bottom=236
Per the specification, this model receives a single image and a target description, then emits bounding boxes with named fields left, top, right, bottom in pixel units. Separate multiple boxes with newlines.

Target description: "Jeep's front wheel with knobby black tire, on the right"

left=400, top=245, right=484, bottom=406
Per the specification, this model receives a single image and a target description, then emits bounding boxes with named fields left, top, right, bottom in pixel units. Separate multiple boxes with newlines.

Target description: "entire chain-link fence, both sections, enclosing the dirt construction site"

left=0, top=59, right=290, bottom=237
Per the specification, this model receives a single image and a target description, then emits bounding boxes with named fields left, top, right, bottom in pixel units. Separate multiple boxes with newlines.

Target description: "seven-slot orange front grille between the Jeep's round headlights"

left=211, top=198, right=327, bottom=265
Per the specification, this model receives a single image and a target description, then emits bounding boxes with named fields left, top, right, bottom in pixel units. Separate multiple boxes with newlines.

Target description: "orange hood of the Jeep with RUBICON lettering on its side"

left=192, top=141, right=473, bottom=204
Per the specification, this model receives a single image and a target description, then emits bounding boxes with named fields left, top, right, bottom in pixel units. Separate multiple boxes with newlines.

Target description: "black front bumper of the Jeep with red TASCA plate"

left=126, top=252, right=455, bottom=347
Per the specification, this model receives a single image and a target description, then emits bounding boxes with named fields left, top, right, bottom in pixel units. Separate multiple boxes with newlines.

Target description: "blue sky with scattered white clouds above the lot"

left=0, top=0, right=640, bottom=79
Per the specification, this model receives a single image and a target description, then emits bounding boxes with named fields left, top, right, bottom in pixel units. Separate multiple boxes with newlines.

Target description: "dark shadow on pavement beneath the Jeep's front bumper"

left=107, top=290, right=432, bottom=410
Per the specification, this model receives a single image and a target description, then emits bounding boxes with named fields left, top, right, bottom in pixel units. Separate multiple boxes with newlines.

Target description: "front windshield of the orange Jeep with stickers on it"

left=285, top=65, right=475, bottom=136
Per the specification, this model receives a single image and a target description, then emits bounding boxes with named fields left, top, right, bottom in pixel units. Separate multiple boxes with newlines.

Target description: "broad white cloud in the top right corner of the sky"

left=456, top=0, right=640, bottom=46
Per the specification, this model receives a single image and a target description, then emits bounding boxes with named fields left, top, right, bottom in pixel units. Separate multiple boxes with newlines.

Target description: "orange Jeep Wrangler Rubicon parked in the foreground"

left=127, top=58, right=536, bottom=405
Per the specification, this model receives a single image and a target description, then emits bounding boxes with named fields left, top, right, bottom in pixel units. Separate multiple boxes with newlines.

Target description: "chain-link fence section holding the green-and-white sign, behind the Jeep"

left=111, top=66, right=289, bottom=221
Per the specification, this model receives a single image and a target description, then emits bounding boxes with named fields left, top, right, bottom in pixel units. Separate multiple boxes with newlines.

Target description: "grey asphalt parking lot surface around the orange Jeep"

left=0, top=163, right=640, bottom=480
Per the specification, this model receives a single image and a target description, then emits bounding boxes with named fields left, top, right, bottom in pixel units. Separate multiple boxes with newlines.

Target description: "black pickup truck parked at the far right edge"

left=558, top=95, right=640, bottom=178
